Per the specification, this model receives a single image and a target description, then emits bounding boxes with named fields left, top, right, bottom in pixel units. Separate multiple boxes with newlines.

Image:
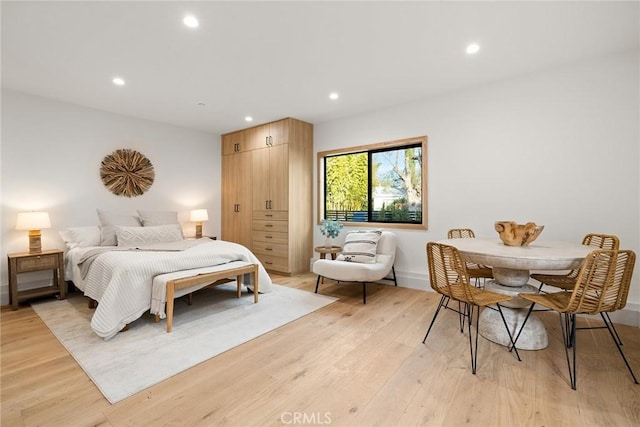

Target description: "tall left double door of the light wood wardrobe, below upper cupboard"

left=222, top=151, right=252, bottom=248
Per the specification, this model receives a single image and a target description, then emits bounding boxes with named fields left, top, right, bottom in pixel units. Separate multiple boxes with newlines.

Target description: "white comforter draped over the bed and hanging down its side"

left=68, top=239, right=271, bottom=339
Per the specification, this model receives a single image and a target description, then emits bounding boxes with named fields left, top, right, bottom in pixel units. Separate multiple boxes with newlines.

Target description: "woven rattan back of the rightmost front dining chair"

left=564, top=249, right=636, bottom=314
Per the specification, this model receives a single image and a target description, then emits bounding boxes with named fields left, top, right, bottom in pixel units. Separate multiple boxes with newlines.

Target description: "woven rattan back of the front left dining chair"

left=427, top=242, right=474, bottom=304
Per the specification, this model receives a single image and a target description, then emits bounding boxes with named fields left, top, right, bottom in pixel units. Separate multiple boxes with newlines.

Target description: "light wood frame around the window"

left=316, top=135, right=429, bottom=230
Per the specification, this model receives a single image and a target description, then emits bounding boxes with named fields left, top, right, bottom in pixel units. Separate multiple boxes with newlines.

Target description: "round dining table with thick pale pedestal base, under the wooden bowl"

left=438, top=238, right=594, bottom=350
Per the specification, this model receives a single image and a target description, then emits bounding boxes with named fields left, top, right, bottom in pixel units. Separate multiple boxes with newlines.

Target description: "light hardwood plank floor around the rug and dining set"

left=0, top=274, right=640, bottom=426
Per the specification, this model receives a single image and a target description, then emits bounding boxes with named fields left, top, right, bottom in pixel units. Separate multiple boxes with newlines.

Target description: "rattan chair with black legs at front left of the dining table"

left=422, top=242, right=520, bottom=375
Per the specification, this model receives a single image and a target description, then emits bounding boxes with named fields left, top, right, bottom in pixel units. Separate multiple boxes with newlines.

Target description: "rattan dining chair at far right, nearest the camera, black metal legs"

left=515, top=249, right=638, bottom=390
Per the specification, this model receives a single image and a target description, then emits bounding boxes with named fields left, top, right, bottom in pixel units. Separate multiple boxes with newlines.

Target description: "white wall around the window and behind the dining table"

left=314, top=51, right=640, bottom=326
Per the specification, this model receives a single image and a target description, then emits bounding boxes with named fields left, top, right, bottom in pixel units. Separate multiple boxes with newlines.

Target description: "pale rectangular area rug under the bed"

left=32, top=282, right=336, bottom=403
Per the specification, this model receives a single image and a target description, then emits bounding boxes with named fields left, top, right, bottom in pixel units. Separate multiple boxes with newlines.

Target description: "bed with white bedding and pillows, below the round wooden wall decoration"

left=61, top=216, right=272, bottom=339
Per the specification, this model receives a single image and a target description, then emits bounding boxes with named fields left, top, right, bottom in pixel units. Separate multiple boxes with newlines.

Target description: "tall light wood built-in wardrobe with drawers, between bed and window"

left=222, top=118, right=313, bottom=274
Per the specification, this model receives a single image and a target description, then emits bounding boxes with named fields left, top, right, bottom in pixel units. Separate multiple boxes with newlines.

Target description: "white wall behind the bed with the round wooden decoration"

left=0, top=90, right=221, bottom=304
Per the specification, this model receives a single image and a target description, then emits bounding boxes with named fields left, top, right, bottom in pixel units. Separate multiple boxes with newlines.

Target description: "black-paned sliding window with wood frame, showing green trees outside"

left=318, top=136, right=427, bottom=229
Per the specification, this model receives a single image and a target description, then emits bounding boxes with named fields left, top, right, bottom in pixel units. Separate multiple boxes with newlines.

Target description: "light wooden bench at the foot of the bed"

left=154, top=261, right=259, bottom=333
